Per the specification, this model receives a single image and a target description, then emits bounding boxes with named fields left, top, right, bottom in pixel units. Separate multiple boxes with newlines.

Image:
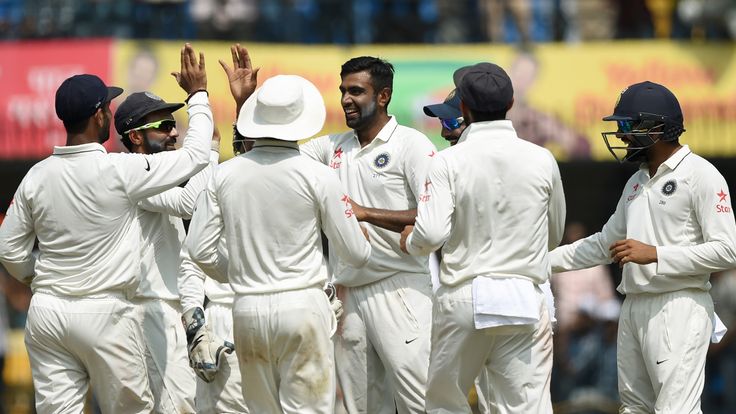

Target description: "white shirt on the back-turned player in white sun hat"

left=185, top=138, right=371, bottom=295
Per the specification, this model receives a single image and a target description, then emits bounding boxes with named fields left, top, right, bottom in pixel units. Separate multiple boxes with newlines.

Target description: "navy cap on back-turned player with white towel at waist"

left=452, top=62, right=514, bottom=112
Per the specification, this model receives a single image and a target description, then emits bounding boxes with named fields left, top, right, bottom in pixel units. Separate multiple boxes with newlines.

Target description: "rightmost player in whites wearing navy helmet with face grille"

left=550, top=82, right=736, bottom=413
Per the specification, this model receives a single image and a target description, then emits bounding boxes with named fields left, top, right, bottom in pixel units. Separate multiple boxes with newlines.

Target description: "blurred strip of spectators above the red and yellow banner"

left=0, top=0, right=736, bottom=44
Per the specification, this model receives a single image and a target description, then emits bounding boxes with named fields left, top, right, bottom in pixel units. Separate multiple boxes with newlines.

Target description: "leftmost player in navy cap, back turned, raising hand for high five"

left=0, top=45, right=213, bottom=414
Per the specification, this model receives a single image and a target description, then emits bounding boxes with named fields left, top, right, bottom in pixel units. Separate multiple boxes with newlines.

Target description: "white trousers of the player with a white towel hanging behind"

left=426, top=280, right=552, bottom=414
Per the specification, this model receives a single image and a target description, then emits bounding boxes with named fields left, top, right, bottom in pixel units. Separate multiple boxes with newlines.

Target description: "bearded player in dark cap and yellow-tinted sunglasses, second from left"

left=115, top=92, right=220, bottom=414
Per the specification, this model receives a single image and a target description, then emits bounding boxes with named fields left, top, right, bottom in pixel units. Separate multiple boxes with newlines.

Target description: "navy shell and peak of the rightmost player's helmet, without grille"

left=603, top=81, right=683, bottom=125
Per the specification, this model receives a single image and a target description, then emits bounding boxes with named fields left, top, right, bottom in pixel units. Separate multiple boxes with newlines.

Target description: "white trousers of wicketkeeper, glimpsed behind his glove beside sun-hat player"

left=197, top=302, right=249, bottom=414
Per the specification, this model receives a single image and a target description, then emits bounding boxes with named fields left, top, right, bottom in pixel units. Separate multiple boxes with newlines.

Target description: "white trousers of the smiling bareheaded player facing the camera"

left=335, top=273, right=432, bottom=414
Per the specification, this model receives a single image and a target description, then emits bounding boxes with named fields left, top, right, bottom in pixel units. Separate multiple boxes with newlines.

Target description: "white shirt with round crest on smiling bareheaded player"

left=301, top=116, right=437, bottom=286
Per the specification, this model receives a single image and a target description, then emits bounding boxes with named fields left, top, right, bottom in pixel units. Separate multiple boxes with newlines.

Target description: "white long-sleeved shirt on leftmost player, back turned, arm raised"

left=0, top=92, right=213, bottom=296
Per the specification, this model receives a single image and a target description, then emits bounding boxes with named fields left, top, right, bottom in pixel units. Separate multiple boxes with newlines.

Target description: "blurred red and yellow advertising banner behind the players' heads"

left=0, top=40, right=736, bottom=161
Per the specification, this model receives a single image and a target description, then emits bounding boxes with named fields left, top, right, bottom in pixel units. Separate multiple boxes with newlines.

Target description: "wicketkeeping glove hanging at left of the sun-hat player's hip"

left=181, top=308, right=235, bottom=382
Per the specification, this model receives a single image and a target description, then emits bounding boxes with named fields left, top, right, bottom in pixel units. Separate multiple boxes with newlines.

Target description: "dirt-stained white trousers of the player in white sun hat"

left=233, top=288, right=337, bottom=414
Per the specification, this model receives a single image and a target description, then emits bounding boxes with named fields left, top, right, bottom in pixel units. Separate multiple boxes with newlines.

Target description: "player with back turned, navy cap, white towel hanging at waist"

left=402, top=63, right=565, bottom=414
